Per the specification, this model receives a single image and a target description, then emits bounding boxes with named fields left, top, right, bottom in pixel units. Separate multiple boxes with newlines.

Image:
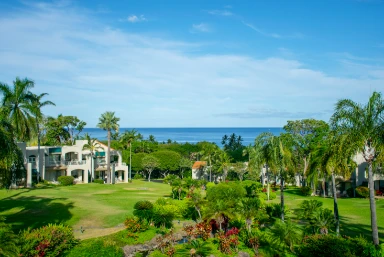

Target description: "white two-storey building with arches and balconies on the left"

left=18, top=140, right=128, bottom=187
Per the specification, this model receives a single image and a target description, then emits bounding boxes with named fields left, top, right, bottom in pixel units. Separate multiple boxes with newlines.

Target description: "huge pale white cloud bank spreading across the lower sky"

left=0, top=2, right=384, bottom=127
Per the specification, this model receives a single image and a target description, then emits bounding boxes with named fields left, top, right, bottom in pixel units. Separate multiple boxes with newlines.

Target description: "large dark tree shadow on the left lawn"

left=0, top=196, right=73, bottom=232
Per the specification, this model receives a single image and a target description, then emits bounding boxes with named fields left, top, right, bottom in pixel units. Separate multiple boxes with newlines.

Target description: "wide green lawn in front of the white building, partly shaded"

left=0, top=180, right=171, bottom=239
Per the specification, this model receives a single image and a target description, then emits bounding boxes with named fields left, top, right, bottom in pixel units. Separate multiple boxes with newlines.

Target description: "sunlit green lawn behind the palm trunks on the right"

left=271, top=189, right=384, bottom=243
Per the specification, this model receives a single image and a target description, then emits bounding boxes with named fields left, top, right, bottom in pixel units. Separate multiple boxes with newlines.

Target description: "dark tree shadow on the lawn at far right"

left=340, top=217, right=384, bottom=243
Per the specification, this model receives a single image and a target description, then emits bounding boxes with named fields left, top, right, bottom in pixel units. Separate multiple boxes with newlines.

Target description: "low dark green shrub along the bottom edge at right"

left=296, top=235, right=373, bottom=257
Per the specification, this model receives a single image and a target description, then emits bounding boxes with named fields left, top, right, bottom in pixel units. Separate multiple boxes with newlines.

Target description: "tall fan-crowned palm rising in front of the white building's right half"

left=97, top=112, right=120, bottom=183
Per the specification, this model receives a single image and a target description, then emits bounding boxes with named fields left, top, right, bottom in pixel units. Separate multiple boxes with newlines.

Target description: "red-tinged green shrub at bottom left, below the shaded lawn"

left=20, top=224, right=78, bottom=257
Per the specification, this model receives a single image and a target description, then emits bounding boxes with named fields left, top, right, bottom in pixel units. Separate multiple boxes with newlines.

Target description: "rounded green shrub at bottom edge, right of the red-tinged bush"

left=66, top=239, right=124, bottom=257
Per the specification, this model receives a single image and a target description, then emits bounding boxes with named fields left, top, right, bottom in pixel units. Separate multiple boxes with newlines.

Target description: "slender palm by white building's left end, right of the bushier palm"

left=32, top=93, right=56, bottom=181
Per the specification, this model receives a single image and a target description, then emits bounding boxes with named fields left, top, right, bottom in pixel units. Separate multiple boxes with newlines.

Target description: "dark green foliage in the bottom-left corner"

left=0, top=216, right=19, bottom=256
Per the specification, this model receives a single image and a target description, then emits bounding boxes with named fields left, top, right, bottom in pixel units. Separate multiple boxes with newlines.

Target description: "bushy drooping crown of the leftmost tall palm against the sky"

left=0, top=78, right=36, bottom=141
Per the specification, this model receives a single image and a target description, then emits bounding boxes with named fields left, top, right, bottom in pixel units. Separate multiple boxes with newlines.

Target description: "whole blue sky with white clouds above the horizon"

left=0, top=0, right=384, bottom=128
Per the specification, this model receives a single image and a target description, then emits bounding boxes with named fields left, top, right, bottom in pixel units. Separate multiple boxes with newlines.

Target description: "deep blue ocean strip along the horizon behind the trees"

left=80, top=128, right=283, bottom=146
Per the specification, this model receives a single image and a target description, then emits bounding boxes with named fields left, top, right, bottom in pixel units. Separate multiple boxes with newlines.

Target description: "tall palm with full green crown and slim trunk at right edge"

left=331, top=92, right=384, bottom=245
